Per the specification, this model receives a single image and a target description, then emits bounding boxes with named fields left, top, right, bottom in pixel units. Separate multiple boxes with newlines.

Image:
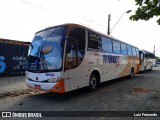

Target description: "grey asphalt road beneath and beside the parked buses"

left=0, top=68, right=160, bottom=120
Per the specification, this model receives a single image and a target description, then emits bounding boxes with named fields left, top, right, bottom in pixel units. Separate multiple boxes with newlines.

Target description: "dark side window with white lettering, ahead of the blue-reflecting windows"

left=88, top=31, right=101, bottom=50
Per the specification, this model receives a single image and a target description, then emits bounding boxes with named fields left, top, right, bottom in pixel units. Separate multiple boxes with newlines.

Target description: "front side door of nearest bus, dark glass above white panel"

left=64, top=27, right=89, bottom=90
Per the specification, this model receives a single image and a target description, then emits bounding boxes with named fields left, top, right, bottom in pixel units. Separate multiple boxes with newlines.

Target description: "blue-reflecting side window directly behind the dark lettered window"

left=101, top=37, right=112, bottom=52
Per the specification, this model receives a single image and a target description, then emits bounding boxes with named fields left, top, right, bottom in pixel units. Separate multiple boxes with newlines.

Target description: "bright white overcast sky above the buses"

left=0, top=0, right=160, bottom=57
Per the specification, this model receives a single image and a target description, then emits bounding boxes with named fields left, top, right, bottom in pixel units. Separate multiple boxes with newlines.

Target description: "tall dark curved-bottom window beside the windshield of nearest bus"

left=65, top=27, right=85, bottom=70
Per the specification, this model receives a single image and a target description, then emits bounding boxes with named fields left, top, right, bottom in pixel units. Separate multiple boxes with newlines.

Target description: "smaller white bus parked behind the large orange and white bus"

left=139, top=50, right=156, bottom=72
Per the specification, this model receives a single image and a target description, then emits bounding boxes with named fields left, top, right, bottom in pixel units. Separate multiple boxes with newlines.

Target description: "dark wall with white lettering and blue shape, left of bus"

left=0, top=41, right=28, bottom=76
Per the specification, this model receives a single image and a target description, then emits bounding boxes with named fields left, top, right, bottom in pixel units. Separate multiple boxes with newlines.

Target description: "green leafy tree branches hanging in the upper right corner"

left=130, top=0, right=160, bottom=25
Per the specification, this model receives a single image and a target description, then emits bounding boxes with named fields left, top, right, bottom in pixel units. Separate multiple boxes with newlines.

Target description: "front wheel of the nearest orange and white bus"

left=89, top=74, right=98, bottom=91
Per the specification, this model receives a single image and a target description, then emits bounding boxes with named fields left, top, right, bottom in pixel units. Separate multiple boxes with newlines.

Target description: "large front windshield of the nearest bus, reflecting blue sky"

left=28, top=26, right=66, bottom=72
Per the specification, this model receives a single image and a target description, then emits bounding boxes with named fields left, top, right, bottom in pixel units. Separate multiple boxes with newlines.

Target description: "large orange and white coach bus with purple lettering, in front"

left=26, top=24, right=139, bottom=93
